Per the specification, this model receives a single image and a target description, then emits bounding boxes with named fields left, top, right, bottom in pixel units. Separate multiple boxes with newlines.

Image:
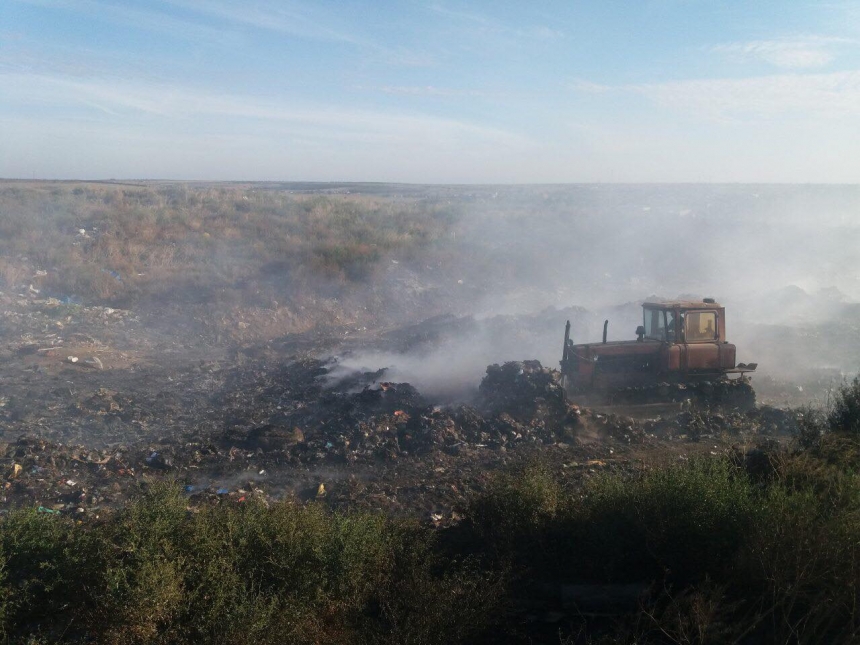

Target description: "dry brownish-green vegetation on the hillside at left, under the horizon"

left=0, top=182, right=453, bottom=304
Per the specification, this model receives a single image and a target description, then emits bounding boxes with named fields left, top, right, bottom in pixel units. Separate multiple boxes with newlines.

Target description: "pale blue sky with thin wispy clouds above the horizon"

left=0, top=0, right=860, bottom=183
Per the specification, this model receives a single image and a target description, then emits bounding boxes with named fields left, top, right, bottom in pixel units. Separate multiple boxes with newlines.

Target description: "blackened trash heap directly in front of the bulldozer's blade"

left=224, top=361, right=579, bottom=463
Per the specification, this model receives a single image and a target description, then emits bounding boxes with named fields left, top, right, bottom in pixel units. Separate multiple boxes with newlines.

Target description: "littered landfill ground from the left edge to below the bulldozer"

left=0, top=276, right=798, bottom=526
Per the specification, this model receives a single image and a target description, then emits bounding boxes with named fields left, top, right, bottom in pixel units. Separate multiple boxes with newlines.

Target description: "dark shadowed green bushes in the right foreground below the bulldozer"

left=472, top=452, right=860, bottom=643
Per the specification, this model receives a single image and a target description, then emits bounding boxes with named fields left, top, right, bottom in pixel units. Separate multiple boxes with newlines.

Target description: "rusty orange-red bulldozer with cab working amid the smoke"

left=561, top=298, right=758, bottom=410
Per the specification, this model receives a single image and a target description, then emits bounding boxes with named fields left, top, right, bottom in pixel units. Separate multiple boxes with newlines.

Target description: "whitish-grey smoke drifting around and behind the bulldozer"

left=328, top=185, right=860, bottom=399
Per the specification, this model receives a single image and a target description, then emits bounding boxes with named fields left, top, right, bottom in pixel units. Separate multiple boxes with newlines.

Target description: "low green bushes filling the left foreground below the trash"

left=0, top=485, right=498, bottom=643
